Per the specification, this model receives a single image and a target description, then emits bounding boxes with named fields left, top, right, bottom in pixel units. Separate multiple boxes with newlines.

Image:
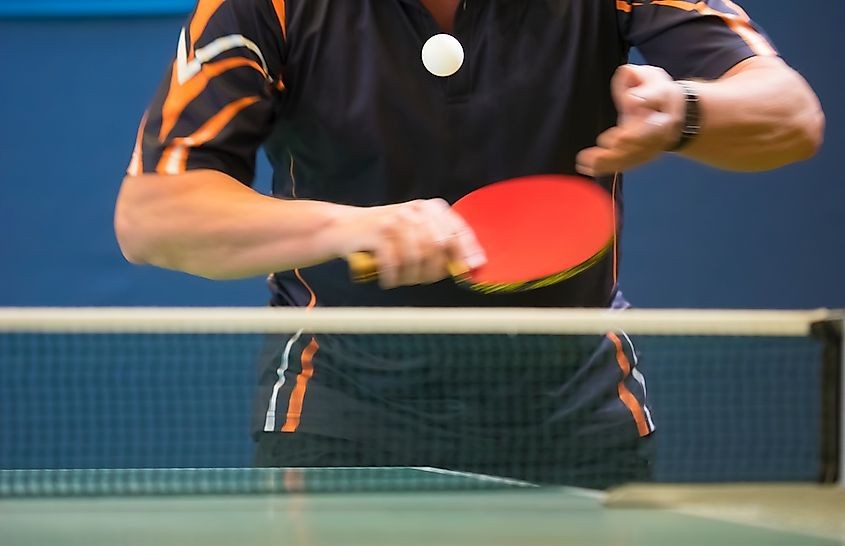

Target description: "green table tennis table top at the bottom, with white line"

left=0, top=468, right=845, bottom=546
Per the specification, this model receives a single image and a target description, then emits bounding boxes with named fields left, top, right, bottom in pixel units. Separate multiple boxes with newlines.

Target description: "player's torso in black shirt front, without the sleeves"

left=266, top=0, right=627, bottom=307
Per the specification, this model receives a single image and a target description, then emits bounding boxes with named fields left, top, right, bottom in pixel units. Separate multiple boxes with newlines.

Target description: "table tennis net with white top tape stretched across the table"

left=0, top=309, right=842, bottom=496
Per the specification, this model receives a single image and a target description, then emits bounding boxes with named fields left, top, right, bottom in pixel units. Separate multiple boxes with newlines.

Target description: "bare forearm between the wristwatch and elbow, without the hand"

left=683, top=58, right=824, bottom=171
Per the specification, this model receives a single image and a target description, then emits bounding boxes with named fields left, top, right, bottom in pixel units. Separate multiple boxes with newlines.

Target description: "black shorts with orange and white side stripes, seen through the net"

left=251, top=333, right=653, bottom=488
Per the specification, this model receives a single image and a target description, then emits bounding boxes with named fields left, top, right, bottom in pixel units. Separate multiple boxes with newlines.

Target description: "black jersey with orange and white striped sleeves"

left=129, top=0, right=776, bottom=307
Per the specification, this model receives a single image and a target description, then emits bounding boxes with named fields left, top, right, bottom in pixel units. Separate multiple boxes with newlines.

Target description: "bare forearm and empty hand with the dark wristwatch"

left=578, top=57, right=824, bottom=176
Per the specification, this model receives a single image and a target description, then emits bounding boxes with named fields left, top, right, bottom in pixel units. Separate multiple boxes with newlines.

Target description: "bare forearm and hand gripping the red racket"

left=115, top=170, right=483, bottom=287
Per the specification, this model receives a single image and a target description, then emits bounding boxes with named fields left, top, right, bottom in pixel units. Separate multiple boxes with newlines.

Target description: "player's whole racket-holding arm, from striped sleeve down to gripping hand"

left=109, top=0, right=484, bottom=288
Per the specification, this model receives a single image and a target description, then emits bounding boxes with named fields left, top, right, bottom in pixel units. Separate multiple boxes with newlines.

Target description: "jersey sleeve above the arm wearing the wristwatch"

left=616, top=0, right=778, bottom=80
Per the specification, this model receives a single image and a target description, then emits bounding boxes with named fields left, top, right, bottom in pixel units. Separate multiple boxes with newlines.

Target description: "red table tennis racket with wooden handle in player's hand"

left=347, top=175, right=616, bottom=293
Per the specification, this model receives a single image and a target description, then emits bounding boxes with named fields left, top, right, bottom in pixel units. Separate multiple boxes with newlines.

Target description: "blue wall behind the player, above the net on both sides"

left=0, top=0, right=845, bottom=308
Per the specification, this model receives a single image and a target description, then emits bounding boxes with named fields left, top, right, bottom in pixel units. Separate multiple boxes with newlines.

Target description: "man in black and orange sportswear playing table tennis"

left=115, top=0, right=824, bottom=486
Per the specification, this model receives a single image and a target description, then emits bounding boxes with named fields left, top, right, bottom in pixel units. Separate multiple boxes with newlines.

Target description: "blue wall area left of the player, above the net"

left=0, top=16, right=267, bottom=305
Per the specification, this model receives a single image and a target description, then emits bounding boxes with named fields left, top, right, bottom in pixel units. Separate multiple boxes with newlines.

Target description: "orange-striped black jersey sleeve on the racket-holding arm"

left=127, top=0, right=285, bottom=184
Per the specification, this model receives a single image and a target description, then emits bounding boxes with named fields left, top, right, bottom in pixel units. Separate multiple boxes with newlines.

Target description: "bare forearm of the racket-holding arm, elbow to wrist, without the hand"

left=115, top=171, right=353, bottom=279
